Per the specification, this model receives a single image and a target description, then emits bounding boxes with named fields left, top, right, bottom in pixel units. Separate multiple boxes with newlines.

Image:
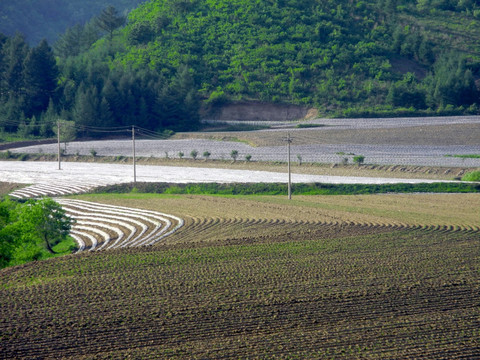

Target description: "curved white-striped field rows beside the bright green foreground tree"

left=55, top=198, right=184, bottom=251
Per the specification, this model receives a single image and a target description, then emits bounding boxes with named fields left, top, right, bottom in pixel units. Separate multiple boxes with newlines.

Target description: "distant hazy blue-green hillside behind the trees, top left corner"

left=0, top=0, right=145, bottom=44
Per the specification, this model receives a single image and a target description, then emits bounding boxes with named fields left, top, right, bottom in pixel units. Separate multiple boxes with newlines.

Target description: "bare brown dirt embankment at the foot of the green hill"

left=202, top=101, right=317, bottom=121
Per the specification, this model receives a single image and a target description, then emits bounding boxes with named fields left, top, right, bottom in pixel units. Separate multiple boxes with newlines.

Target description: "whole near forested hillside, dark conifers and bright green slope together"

left=0, top=0, right=480, bottom=136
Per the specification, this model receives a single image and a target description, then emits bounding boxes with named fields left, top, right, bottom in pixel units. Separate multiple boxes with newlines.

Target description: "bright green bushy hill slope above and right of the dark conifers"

left=110, top=0, right=480, bottom=114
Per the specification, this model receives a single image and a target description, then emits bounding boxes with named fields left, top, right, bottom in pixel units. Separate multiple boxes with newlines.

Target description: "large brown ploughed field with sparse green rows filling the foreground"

left=0, top=194, right=480, bottom=359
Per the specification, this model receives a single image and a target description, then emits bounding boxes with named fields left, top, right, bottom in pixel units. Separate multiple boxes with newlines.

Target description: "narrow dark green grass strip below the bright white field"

left=93, top=182, right=480, bottom=195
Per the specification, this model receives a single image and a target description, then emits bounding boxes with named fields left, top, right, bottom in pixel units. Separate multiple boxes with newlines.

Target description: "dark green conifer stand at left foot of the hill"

left=0, top=7, right=200, bottom=141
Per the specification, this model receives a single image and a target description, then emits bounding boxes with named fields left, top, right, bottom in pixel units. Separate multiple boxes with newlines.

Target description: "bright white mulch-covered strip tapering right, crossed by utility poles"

left=0, top=161, right=460, bottom=195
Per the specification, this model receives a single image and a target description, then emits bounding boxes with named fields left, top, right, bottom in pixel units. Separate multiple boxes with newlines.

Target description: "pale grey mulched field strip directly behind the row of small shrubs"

left=12, top=139, right=480, bottom=167
